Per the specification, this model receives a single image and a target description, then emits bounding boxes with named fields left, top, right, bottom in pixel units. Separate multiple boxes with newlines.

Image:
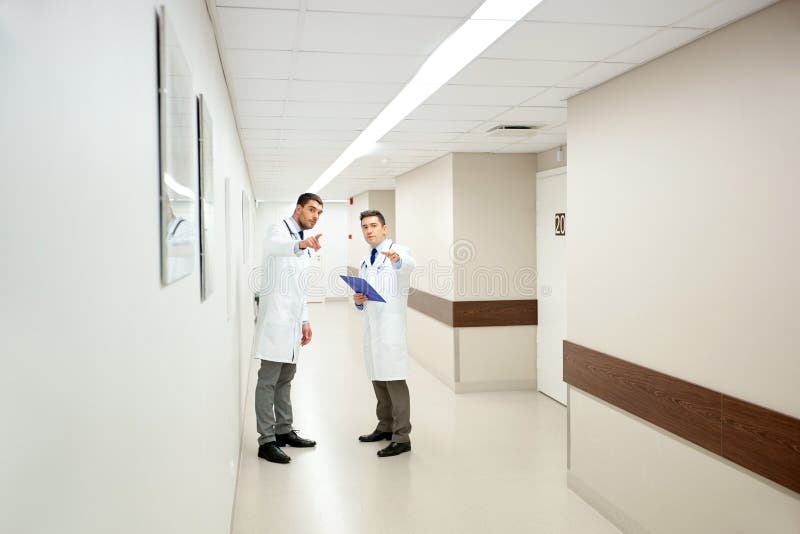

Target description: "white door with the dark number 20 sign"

left=536, top=167, right=569, bottom=405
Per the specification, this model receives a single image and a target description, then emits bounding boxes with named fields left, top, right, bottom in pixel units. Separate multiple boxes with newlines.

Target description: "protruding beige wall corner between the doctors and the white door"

left=396, top=153, right=536, bottom=392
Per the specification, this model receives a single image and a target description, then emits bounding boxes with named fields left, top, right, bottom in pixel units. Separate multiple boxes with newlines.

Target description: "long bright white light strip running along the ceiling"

left=308, top=0, right=542, bottom=193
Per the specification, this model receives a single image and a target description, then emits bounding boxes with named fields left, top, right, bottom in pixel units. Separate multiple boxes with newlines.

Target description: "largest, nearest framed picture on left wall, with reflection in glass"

left=156, top=7, right=197, bottom=286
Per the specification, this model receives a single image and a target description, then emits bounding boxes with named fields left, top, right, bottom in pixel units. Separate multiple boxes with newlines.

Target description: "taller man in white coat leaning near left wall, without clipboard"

left=253, top=193, right=322, bottom=464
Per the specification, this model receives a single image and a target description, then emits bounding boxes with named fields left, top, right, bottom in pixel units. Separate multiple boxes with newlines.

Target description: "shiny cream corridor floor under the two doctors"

left=233, top=302, right=619, bottom=534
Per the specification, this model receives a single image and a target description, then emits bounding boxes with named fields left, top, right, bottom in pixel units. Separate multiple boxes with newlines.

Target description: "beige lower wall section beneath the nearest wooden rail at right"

left=570, top=389, right=800, bottom=534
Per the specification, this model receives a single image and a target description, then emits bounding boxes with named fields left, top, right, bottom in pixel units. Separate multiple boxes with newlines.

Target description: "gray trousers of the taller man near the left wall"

left=256, top=360, right=297, bottom=445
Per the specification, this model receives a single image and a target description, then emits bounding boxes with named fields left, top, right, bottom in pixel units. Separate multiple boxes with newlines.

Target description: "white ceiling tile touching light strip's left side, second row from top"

left=300, top=11, right=461, bottom=55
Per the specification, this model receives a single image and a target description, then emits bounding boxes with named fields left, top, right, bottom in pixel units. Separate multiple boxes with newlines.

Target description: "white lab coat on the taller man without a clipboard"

left=253, top=219, right=309, bottom=363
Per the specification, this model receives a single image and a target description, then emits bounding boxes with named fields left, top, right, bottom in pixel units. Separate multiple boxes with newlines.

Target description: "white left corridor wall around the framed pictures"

left=0, top=0, right=252, bottom=534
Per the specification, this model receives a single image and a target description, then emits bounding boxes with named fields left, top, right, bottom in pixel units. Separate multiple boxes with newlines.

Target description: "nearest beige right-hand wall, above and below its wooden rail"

left=567, top=0, right=800, bottom=533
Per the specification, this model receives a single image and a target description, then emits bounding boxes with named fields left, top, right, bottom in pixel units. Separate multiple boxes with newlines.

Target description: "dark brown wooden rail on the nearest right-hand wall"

left=564, top=341, right=800, bottom=492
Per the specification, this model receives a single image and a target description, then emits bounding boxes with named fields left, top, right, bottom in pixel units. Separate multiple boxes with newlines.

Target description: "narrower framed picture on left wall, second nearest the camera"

left=197, top=94, right=214, bottom=300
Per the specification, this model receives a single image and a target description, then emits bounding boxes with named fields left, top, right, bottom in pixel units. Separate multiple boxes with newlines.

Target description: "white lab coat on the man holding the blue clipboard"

left=358, top=239, right=416, bottom=380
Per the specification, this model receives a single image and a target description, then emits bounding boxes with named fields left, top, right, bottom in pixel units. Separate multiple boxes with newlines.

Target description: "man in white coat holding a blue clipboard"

left=353, top=210, right=416, bottom=458
